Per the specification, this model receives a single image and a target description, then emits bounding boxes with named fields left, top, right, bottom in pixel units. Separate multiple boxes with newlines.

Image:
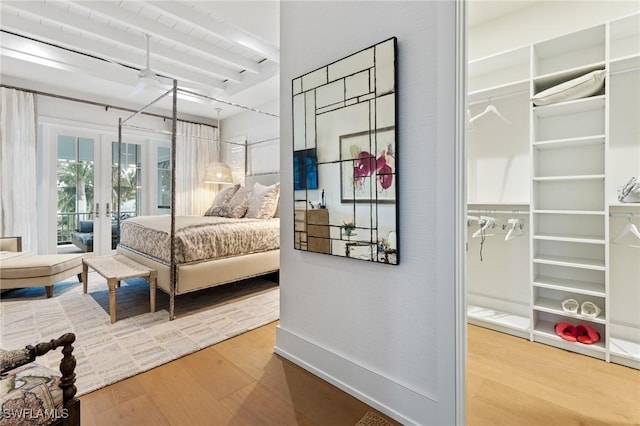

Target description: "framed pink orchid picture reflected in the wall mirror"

left=340, top=127, right=396, bottom=203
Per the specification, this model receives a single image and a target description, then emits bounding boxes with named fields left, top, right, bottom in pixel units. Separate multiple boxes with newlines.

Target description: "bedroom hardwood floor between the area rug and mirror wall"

left=80, top=322, right=398, bottom=426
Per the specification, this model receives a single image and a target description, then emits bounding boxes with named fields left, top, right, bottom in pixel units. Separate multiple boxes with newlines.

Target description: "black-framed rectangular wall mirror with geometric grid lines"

left=292, top=37, right=399, bottom=265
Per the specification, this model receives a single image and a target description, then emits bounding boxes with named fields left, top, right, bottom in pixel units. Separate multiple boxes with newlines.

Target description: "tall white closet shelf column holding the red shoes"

left=531, top=25, right=608, bottom=358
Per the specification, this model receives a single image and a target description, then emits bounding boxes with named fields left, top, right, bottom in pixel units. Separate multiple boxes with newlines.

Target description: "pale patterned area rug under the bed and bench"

left=0, top=271, right=280, bottom=395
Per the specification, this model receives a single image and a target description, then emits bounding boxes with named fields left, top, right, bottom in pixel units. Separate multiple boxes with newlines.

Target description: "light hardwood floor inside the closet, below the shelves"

left=467, top=325, right=640, bottom=426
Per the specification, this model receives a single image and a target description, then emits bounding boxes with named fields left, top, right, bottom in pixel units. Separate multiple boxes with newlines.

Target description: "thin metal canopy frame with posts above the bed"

left=116, top=79, right=280, bottom=320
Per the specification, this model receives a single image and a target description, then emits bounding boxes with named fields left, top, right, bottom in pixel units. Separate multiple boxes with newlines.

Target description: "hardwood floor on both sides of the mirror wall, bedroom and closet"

left=80, top=323, right=640, bottom=426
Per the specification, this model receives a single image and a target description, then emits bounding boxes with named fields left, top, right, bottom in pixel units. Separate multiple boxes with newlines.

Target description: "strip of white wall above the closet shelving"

left=468, top=0, right=640, bottom=60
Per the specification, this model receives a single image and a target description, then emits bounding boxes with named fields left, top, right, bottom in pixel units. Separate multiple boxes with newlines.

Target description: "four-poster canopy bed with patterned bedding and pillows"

left=116, top=81, right=280, bottom=319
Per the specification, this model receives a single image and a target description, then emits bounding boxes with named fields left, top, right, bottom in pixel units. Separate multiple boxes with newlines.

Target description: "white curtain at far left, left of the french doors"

left=0, top=88, right=38, bottom=251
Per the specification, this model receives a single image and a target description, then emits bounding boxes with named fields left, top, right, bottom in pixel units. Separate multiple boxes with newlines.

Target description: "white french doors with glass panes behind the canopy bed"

left=37, top=124, right=143, bottom=255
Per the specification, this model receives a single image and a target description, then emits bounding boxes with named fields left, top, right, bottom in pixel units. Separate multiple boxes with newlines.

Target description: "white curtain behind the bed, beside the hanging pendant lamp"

left=175, top=121, right=219, bottom=216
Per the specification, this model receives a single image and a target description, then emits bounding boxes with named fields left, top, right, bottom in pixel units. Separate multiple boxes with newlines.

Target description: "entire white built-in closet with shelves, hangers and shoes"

left=467, top=10, right=640, bottom=368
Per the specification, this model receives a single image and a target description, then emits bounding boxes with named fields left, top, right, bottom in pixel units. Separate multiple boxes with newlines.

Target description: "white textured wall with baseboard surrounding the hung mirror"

left=276, top=1, right=456, bottom=425
